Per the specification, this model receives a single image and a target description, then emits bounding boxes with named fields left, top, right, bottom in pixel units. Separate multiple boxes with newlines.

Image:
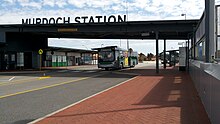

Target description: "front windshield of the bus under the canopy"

left=99, top=51, right=114, bottom=62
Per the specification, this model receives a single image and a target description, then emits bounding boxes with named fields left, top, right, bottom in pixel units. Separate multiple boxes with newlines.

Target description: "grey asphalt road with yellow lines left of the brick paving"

left=0, top=69, right=139, bottom=124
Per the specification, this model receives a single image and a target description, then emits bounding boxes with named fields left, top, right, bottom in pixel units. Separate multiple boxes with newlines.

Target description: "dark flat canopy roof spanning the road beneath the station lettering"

left=0, top=20, right=199, bottom=40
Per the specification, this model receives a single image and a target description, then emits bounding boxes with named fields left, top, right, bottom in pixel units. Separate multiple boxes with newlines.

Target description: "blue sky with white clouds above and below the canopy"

left=0, top=0, right=220, bottom=54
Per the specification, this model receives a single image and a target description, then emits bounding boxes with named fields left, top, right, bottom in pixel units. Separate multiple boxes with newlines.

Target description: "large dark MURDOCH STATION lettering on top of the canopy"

left=22, top=15, right=126, bottom=25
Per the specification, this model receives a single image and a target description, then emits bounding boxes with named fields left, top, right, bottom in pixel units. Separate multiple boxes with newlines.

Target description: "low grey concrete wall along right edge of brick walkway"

left=190, top=60, right=220, bottom=124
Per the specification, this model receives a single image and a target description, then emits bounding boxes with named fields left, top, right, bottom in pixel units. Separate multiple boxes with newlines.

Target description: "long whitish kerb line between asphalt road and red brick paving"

left=28, top=76, right=137, bottom=124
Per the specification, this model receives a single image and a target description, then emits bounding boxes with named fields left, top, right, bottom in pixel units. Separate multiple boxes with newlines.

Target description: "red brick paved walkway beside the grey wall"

left=35, top=68, right=210, bottom=124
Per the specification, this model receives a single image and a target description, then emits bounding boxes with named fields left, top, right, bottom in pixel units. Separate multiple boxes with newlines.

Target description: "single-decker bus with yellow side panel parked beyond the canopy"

left=93, top=46, right=138, bottom=70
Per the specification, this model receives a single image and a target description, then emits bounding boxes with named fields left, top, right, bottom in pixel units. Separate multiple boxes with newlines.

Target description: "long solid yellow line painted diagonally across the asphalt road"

left=0, top=76, right=90, bottom=99
